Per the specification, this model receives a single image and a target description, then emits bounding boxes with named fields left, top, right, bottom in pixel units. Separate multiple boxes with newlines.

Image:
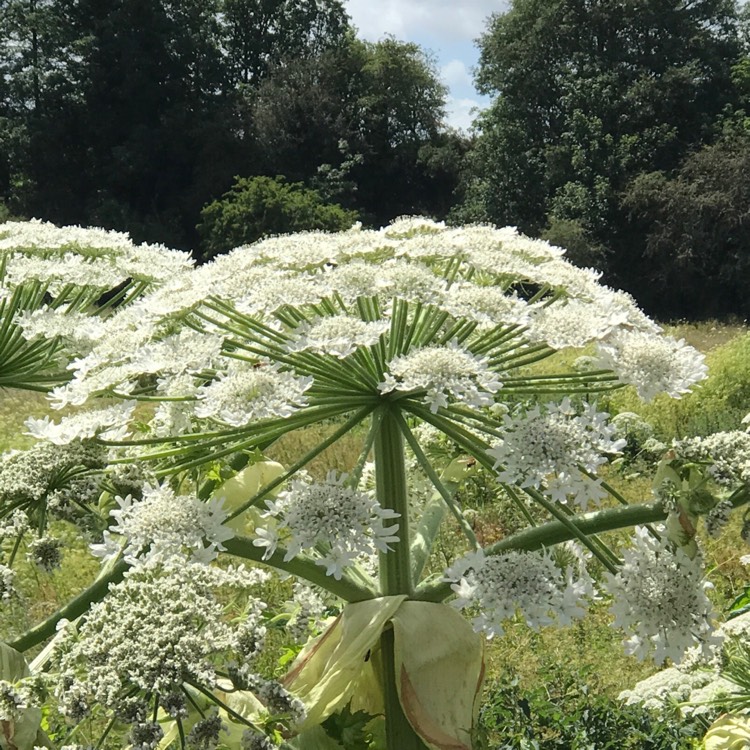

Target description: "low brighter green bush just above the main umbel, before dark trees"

left=198, top=177, right=357, bottom=258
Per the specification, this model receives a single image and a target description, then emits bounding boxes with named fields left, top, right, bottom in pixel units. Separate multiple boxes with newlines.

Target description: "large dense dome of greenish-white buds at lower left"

left=53, top=558, right=276, bottom=741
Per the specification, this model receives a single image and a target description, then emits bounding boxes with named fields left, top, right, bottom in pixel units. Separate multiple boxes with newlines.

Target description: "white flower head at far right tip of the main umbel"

left=599, top=330, right=708, bottom=401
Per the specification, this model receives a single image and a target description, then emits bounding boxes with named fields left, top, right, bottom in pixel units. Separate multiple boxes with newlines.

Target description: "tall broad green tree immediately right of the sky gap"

left=464, top=0, right=741, bottom=284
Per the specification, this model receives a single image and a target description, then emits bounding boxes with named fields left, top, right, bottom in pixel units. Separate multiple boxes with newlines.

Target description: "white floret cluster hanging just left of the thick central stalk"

left=253, top=472, right=398, bottom=580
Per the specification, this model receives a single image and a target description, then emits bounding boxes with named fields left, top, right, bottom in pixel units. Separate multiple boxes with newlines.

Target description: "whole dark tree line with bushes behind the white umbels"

left=0, top=0, right=750, bottom=317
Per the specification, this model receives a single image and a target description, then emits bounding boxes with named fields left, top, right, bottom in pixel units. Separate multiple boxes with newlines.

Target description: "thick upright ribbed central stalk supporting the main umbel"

left=375, top=404, right=426, bottom=750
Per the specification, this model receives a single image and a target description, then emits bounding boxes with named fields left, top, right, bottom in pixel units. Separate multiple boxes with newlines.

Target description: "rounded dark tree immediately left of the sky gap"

left=252, top=35, right=466, bottom=225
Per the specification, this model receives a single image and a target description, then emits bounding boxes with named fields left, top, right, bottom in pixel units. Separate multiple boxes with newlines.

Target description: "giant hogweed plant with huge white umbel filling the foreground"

left=0, top=219, right=747, bottom=750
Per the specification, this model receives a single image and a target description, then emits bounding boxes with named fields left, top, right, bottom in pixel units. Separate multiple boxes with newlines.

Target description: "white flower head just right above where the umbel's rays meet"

left=378, top=342, right=502, bottom=413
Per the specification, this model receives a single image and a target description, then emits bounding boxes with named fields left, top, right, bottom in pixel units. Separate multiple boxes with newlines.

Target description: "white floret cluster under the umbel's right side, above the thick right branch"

left=488, top=398, right=626, bottom=510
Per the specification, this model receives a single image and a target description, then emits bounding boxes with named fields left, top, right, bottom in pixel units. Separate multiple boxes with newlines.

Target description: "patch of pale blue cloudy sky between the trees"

left=344, top=0, right=507, bottom=129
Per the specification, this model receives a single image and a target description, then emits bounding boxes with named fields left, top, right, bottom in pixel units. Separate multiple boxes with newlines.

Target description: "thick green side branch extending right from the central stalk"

left=414, top=497, right=680, bottom=602
